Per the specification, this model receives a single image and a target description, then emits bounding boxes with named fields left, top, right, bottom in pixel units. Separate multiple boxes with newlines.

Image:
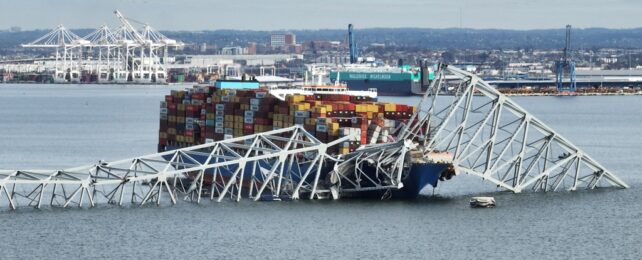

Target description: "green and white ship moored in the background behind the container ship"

left=330, top=64, right=434, bottom=96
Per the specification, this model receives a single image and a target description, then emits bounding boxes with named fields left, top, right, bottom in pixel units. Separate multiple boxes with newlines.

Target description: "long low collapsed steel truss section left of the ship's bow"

left=0, top=126, right=350, bottom=209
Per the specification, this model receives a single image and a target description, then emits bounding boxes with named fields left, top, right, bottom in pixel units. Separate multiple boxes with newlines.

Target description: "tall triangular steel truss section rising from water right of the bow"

left=401, top=64, right=628, bottom=193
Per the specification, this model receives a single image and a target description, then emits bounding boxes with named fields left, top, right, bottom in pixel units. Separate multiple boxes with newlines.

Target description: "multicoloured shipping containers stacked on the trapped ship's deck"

left=158, top=86, right=415, bottom=154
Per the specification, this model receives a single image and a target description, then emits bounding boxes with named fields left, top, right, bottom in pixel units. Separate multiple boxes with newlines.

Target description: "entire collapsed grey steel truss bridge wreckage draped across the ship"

left=0, top=65, right=628, bottom=209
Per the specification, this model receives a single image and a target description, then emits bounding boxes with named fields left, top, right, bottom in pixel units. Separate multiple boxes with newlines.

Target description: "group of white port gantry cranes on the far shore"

left=16, top=10, right=183, bottom=84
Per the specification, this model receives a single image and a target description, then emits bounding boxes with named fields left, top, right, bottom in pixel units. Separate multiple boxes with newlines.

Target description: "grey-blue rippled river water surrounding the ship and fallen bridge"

left=0, top=85, right=642, bottom=259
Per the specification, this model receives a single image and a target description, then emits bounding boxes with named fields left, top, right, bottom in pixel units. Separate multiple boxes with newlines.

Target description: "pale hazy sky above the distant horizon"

left=0, top=0, right=642, bottom=30
